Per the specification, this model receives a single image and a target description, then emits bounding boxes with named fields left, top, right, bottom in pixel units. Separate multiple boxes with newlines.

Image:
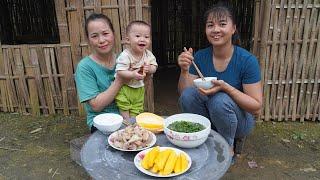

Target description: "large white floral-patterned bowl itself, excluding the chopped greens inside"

left=164, top=113, right=211, bottom=148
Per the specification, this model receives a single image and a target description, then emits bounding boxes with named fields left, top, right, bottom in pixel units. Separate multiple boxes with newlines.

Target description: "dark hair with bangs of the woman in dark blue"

left=204, top=1, right=240, bottom=45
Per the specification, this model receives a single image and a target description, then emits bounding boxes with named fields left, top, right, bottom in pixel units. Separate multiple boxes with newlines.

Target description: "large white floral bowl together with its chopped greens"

left=164, top=113, right=211, bottom=148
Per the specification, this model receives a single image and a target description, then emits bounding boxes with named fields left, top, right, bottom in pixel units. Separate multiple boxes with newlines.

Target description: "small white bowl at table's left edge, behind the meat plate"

left=93, top=113, right=123, bottom=134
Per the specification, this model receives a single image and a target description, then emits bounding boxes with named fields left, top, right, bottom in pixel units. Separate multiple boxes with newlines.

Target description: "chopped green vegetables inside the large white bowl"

left=168, top=121, right=205, bottom=133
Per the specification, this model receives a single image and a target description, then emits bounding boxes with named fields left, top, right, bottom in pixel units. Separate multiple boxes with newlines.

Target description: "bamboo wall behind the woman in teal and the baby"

left=0, top=0, right=154, bottom=115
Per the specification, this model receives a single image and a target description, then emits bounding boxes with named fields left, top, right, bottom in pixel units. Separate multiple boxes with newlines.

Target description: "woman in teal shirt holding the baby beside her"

left=75, top=13, right=123, bottom=133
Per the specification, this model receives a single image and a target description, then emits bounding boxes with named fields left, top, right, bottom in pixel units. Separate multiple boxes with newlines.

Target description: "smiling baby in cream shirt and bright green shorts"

left=116, top=21, right=158, bottom=120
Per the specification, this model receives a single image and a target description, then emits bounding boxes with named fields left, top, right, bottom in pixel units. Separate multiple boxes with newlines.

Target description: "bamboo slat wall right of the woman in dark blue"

left=253, top=0, right=320, bottom=121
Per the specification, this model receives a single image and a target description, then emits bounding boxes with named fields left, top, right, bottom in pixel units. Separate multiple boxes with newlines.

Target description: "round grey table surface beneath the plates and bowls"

left=81, top=130, right=231, bottom=180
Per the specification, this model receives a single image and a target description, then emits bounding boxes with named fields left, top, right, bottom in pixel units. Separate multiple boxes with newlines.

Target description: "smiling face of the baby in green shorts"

left=128, top=24, right=151, bottom=54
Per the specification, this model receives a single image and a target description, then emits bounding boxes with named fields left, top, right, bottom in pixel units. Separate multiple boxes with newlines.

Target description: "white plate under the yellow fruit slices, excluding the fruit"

left=134, top=147, right=192, bottom=177
